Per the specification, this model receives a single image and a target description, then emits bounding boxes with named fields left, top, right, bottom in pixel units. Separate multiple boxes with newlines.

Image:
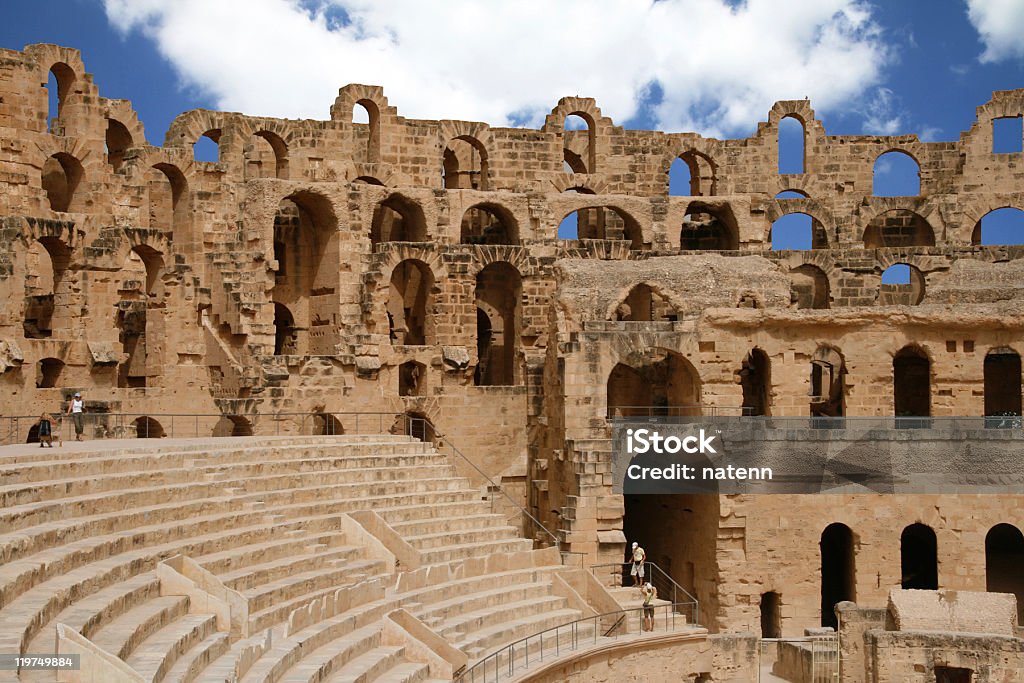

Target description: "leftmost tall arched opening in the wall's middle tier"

left=22, top=237, right=71, bottom=339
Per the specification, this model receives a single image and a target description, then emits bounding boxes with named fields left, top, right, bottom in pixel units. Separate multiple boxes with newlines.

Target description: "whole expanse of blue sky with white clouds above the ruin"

left=0, top=0, right=1024, bottom=255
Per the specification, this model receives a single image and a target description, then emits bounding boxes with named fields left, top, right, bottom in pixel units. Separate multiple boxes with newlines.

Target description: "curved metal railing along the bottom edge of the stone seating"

left=455, top=604, right=695, bottom=683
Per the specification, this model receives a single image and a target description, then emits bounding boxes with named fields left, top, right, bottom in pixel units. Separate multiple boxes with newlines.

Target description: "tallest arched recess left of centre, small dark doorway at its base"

left=270, top=191, right=341, bottom=355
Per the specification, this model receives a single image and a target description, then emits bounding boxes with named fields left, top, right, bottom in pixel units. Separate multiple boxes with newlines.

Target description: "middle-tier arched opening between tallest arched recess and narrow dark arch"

left=387, top=259, right=434, bottom=346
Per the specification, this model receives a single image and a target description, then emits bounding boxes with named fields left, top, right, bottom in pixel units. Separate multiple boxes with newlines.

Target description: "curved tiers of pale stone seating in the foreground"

left=0, top=435, right=581, bottom=682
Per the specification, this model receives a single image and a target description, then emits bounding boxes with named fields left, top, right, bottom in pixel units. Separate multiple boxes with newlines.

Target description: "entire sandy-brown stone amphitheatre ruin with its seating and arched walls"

left=0, top=44, right=1024, bottom=683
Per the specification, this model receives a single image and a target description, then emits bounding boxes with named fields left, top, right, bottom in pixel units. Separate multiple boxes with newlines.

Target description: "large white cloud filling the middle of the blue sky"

left=104, top=0, right=888, bottom=134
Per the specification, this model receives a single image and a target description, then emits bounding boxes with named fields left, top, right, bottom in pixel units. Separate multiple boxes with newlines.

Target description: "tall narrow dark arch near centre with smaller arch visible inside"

left=473, top=262, right=522, bottom=386
